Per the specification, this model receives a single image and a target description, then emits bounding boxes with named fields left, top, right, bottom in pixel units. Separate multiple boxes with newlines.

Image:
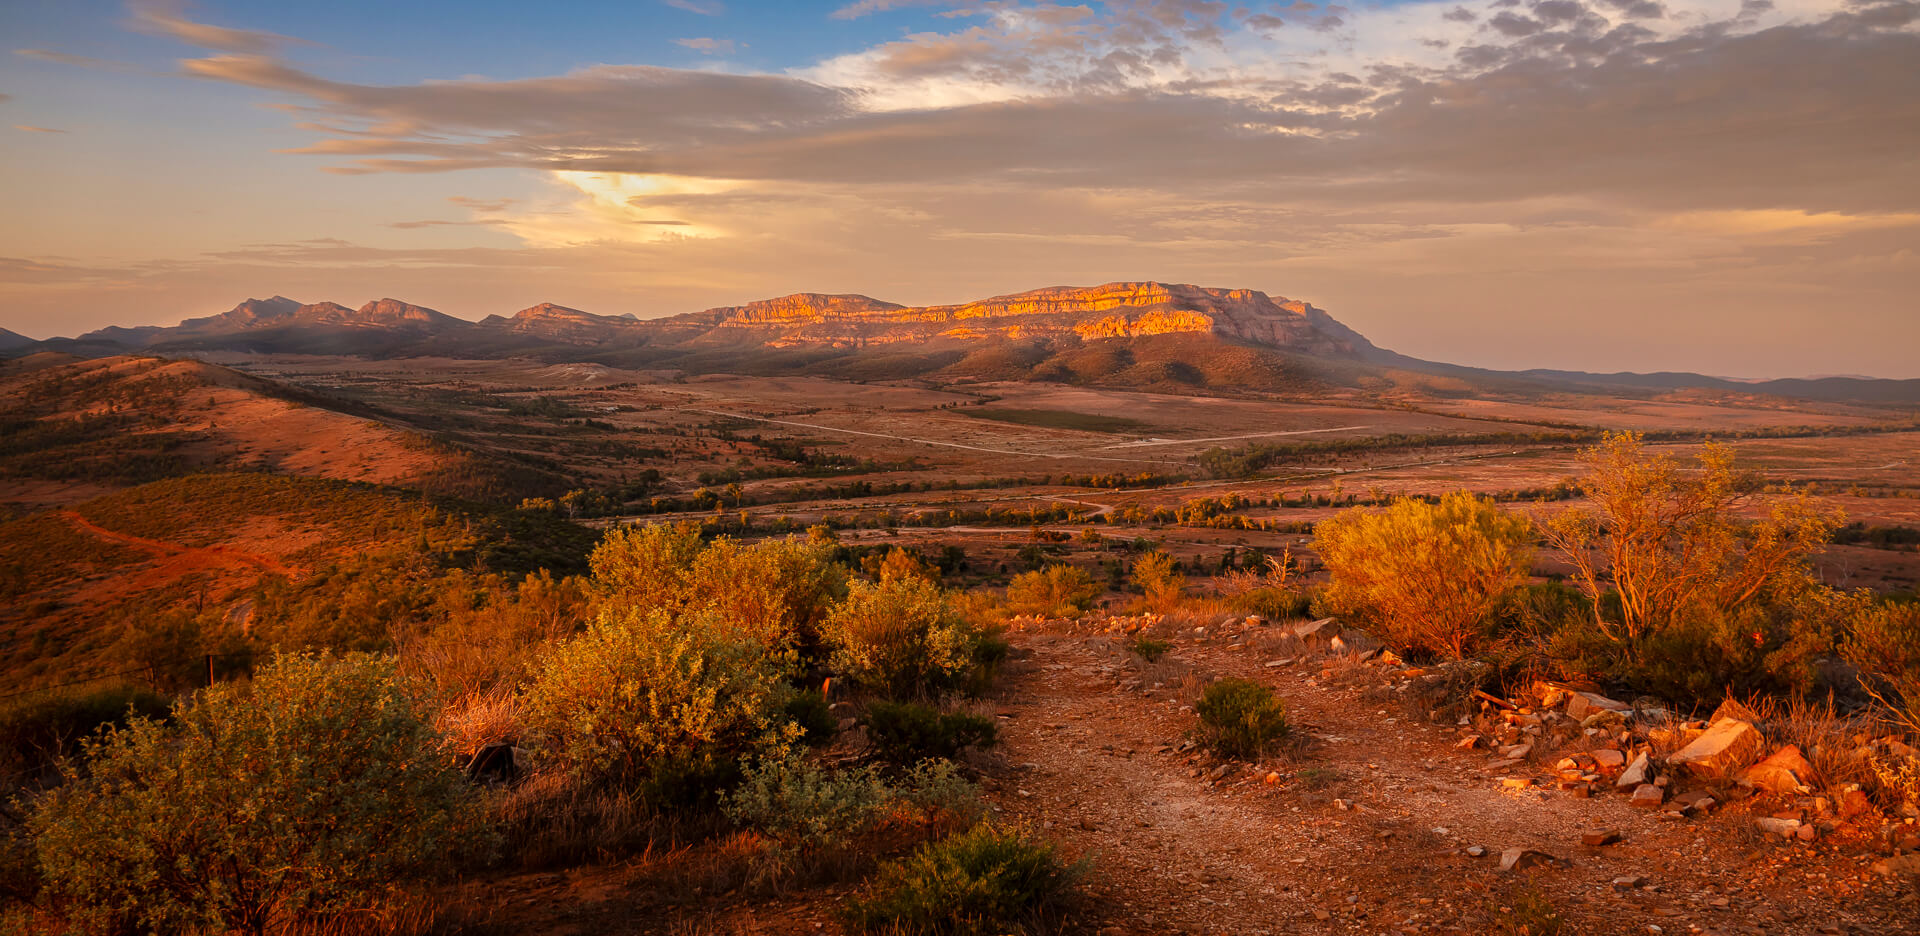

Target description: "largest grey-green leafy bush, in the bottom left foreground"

left=29, top=656, right=484, bottom=932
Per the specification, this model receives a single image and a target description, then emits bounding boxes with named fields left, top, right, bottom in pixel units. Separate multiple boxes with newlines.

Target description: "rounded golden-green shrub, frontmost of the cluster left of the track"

left=522, top=608, right=801, bottom=802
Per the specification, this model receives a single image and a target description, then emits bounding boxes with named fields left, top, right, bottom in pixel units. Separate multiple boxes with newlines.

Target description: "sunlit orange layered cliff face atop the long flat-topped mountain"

left=662, top=282, right=1373, bottom=355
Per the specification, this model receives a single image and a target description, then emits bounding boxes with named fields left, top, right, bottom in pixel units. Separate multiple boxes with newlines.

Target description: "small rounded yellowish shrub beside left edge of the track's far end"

left=822, top=577, right=979, bottom=698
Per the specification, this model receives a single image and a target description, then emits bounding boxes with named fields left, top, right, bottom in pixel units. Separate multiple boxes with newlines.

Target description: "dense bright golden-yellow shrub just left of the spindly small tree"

left=1313, top=491, right=1532, bottom=660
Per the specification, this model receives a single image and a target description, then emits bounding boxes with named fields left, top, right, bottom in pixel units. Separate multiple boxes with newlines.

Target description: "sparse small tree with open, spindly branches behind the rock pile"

left=1546, top=432, right=1839, bottom=644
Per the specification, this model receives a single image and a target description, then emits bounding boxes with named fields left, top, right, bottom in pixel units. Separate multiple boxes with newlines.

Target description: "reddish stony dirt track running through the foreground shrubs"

left=995, top=633, right=1920, bottom=934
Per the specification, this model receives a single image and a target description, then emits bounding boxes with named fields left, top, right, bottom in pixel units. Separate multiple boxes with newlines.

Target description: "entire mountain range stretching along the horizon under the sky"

left=0, top=282, right=1920, bottom=403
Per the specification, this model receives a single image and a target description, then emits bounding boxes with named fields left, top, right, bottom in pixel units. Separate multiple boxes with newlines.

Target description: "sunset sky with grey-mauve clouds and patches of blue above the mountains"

left=0, top=0, right=1920, bottom=378
